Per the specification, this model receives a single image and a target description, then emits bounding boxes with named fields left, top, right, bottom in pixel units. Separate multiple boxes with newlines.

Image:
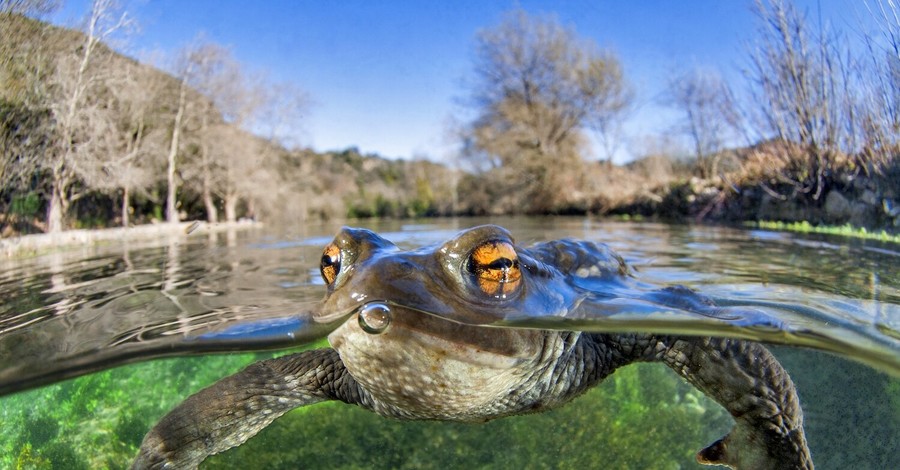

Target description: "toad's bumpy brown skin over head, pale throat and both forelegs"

left=133, top=226, right=813, bottom=469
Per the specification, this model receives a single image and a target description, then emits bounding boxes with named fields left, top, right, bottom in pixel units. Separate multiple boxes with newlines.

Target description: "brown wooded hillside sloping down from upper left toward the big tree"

left=0, top=15, right=456, bottom=234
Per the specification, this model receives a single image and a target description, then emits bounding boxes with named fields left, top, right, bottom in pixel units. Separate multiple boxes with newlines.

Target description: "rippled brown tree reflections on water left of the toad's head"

left=0, top=231, right=320, bottom=394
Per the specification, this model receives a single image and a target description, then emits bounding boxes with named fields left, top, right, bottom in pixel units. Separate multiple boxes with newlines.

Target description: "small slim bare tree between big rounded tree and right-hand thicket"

left=664, top=69, right=740, bottom=178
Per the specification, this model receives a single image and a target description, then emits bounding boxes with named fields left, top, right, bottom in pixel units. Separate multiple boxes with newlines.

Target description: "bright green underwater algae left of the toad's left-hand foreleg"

left=0, top=354, right=271, bottom=470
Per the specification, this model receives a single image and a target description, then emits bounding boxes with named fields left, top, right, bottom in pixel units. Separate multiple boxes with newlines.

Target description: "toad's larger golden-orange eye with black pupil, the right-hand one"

left=467, top=241, right=522, bottom=299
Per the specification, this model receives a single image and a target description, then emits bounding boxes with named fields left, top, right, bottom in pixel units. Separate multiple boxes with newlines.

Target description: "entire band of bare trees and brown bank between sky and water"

left=0, top=0, right=900, bottom=236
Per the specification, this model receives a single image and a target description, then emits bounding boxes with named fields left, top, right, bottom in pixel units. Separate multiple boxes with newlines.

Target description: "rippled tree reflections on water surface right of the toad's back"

left=630, top=225, right=900, bottom=304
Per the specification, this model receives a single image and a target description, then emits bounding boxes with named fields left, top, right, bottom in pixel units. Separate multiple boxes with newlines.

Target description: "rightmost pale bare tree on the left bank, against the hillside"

left=175, top=41, right=307, bottom=222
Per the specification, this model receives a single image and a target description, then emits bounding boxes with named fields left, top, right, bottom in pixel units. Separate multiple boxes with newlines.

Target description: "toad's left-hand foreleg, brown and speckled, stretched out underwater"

left=132, top=349, right=358, bottom=469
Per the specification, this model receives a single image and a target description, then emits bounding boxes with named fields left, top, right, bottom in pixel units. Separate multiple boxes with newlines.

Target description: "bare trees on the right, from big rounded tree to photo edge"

left=460, top=0, right=900, bottom=212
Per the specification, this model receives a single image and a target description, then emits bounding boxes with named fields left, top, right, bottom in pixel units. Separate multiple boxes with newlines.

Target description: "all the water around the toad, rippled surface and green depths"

left=0, top=218, right=900, bottom=468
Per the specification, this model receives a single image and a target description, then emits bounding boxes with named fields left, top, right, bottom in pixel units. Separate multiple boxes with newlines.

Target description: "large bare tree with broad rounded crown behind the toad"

left=465, top=11, right=630, bottom=211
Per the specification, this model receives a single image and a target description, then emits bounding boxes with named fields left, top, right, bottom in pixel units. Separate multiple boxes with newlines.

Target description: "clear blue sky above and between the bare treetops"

left=53, top=0, right=865, bottom=161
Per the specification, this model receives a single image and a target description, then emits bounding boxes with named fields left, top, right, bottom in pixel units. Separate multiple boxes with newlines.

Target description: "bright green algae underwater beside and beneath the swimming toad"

left=0, top=354, right=730, bottom=469
